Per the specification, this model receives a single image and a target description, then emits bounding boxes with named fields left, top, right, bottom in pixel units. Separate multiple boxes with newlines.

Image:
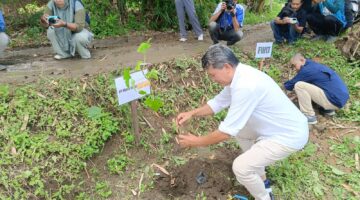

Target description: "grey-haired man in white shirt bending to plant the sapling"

left=176, top=44, right=309, bottom=200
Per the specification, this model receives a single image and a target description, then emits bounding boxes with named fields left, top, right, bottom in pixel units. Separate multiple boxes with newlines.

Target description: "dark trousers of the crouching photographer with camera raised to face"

left=209, top=22, right=243, bottom=45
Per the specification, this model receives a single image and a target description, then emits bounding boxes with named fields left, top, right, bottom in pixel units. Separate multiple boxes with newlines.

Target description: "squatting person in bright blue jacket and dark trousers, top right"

left=307, top=0, right=347, bottom=42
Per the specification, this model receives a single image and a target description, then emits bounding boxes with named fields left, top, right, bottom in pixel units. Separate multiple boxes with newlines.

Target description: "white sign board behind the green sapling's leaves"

left=115, top=70, right=150, bottom=105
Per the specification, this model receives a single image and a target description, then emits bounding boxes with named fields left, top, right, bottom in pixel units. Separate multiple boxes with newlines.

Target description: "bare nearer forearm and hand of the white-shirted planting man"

left=178, top=130, right=231, bottom=147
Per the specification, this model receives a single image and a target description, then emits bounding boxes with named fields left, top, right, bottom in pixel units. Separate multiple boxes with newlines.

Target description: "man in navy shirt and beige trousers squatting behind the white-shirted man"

left=284, top=53, right=349, bottom=124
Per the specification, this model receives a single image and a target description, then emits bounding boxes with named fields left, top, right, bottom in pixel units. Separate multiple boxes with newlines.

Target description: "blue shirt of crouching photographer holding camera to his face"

left=213, top=3, right=245, bottom=29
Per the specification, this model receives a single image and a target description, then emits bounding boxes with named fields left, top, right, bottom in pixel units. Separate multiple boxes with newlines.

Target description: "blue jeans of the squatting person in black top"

left=270, top=21, right=301, bottom=44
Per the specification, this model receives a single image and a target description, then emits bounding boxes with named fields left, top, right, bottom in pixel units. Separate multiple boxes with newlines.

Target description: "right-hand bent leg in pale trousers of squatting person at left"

left=72, top=29, right=93, bottom=58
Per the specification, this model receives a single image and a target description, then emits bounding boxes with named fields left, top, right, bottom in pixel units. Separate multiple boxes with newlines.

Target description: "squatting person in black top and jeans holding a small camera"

left=270, top=0, right=306, bottom=44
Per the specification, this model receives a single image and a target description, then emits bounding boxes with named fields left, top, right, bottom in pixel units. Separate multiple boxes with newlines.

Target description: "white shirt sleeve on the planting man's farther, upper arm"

left=207, top=86, right=231, bottom=114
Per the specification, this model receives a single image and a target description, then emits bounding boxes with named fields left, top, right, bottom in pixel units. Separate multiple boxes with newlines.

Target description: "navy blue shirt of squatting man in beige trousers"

left=284, top=59, right=349, bottom=108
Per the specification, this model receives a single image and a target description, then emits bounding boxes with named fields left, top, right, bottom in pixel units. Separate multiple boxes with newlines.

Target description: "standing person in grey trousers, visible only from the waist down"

left=175, top=0, right=204, bottom=42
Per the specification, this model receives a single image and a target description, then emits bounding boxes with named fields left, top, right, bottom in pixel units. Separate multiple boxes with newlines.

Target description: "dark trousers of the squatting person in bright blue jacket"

left=307, top=13, right=343, bottom=36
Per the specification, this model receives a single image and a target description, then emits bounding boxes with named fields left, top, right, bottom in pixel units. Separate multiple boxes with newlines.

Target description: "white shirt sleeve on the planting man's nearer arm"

left=219, top=88, right=260, bottom=136
